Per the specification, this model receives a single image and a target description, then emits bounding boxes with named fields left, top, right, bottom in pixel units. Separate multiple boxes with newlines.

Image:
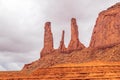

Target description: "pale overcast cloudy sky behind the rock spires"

left=0, top=0, right=119, bottom=71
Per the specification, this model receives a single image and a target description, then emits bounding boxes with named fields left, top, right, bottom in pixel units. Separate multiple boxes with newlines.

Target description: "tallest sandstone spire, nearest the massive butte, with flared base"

left=68, top=18, right=85, bottom=51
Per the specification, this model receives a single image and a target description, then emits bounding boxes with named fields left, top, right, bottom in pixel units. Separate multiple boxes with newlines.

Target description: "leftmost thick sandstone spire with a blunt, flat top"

left=41, top=22, right=53, bottom=57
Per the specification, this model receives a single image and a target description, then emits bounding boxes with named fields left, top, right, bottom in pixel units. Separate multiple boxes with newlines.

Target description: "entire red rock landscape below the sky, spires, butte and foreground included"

left=0, top=3, right=120, bottom=80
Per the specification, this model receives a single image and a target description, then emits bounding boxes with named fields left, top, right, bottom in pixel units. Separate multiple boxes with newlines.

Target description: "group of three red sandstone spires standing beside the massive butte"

left=41, top=18, right=85, bottom=57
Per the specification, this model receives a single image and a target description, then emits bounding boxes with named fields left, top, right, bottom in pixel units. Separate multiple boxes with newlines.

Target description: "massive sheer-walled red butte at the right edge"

left=90, top=3, right=120, bottom=48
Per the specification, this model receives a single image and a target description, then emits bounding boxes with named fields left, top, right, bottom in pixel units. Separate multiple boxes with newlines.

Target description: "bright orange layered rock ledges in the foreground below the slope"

left=0, top=61, right=120, bottom=80
